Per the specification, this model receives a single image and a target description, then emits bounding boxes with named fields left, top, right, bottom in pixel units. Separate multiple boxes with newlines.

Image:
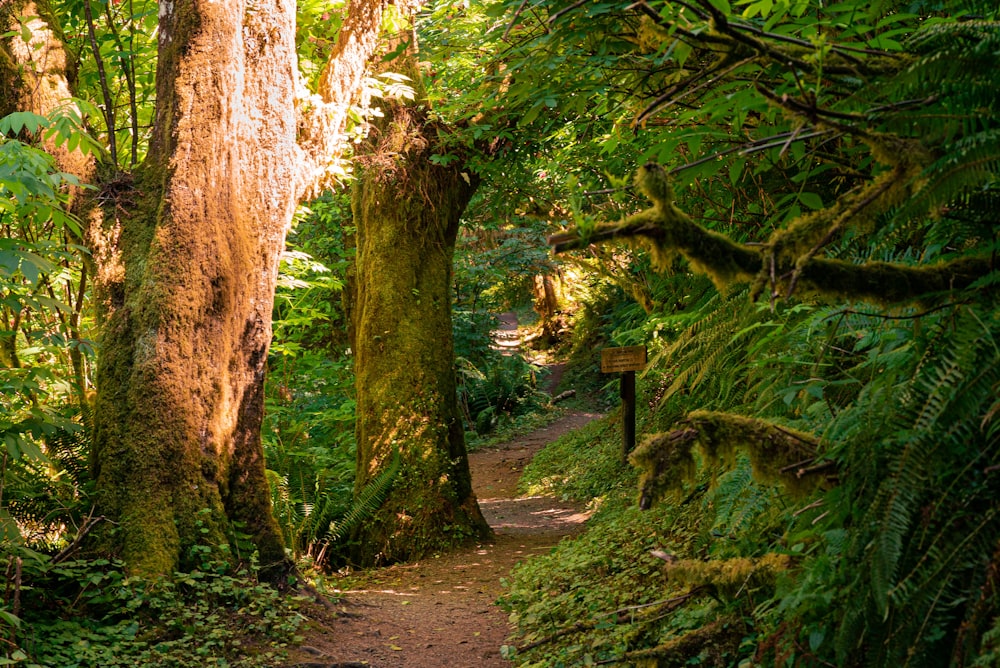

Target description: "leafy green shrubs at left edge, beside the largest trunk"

left=0, top=111, right=94, bottom=547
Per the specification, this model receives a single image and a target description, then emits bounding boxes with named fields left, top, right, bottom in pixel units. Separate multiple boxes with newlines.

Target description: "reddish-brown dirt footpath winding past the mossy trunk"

left=286, top=412, right=598, bottom=668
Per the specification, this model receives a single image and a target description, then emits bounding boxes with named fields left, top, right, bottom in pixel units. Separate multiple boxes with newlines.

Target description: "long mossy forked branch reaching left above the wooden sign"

left=548, top=163, right=996, bottom=304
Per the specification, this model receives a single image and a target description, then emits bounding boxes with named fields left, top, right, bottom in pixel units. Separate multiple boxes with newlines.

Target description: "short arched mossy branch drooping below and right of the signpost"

left=629, top=411, right=827, bottom=509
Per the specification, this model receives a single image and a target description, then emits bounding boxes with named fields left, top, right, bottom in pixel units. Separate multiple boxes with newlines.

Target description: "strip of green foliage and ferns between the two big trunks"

left=263, top=232, right=355, bottom=564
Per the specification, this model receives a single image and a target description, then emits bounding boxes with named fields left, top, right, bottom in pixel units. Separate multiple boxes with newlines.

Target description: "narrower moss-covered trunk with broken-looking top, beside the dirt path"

left=350, top=54, right=489, bottom=564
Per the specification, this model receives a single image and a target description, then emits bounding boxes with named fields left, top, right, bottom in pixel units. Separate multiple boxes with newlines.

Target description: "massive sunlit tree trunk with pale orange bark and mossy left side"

left=7, top=0, right=406, bottom=580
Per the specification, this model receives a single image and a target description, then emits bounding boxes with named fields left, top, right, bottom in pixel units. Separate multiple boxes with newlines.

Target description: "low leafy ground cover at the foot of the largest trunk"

left=0, top=550, right=302, bottom=668
